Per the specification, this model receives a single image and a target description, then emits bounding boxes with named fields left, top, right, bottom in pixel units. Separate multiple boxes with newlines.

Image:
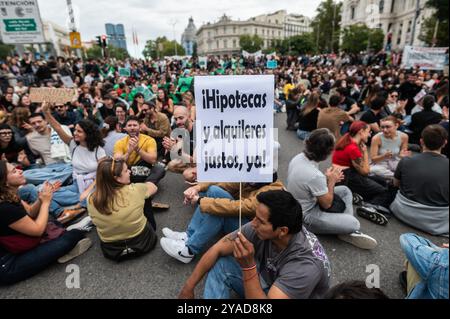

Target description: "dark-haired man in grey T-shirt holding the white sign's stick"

left=179, top=190, right=331, bottom=299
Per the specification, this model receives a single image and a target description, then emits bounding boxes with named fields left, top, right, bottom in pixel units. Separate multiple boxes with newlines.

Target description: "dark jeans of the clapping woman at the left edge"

left=0, top=230, right=84, bottom=285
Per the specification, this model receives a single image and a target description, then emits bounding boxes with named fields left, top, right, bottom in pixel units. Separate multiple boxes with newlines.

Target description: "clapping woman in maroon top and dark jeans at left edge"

left=0, top=160, right=91, bottom=285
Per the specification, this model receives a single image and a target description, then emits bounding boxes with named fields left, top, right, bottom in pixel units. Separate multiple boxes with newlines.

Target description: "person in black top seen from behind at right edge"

left=390, top=125, right=449, bottom=236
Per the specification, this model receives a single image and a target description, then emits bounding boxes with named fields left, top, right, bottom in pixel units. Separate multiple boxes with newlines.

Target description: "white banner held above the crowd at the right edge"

left=402, top=46, right=448, bottom=70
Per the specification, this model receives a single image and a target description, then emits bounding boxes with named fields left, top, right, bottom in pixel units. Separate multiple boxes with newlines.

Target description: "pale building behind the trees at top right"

left=341, top=0, right=433, bottom=51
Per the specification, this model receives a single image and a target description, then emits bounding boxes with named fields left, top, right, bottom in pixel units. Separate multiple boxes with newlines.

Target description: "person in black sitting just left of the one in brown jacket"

left=297, top=93, right=320, bottom=140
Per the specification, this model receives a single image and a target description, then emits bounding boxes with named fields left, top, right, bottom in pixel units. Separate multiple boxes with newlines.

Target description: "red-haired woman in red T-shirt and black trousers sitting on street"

left=333, top=121, right=395, bottom=225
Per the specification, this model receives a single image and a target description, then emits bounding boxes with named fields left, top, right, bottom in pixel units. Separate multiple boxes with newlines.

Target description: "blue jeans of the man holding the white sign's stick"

left=203, top=256, right=245, bottom=299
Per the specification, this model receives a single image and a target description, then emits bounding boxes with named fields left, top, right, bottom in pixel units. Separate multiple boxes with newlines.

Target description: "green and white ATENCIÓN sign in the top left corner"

left=0, top=0, right=45, bottom=44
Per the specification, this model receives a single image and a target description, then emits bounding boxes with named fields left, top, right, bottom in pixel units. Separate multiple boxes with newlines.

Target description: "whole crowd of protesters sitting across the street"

left=0, top=52, right=449, bottom=299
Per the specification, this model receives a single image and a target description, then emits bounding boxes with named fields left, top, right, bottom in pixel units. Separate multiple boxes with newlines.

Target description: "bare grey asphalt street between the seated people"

left=0, top=114, right=448, bottom=299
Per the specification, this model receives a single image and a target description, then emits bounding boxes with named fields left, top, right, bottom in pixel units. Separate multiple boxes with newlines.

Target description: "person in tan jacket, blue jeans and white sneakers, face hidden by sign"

left=161, top=174, right=283, bottom=263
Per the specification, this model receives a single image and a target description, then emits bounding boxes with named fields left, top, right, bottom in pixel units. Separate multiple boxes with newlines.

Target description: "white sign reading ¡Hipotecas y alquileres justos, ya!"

left=194, top=75, right=275, bottom=183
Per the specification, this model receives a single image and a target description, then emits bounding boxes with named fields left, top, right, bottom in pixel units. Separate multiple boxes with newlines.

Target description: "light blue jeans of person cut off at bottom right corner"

left=400, top=234, right=449, bottom=299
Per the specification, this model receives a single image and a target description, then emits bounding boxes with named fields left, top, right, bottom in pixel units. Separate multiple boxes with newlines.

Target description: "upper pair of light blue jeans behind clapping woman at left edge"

left=23, top=163, right=72, bottom=185
